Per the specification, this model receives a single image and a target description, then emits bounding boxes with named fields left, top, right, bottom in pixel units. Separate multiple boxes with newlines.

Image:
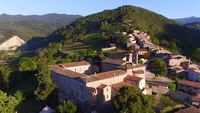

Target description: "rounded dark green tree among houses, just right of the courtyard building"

left=147, top=59, right=167, bottom=76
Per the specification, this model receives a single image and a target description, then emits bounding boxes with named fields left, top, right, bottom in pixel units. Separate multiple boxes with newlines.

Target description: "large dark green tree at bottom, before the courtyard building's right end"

left=112, top=87, right=154, bottom=113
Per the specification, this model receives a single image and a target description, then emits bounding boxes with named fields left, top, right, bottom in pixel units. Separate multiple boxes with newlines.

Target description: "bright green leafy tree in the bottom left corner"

left=0, top=90, right=22, bottom=113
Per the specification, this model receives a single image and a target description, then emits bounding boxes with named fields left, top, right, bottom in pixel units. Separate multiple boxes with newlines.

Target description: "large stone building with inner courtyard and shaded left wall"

left=51, top=61, right=146, bottom=105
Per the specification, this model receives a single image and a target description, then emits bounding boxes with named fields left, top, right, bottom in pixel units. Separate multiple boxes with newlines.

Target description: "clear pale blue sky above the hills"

left=0, top=0, right=200, bottom=18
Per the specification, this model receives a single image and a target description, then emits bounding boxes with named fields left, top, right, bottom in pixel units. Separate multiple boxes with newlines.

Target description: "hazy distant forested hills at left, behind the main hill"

left=0, top=14, right=80, bottom=41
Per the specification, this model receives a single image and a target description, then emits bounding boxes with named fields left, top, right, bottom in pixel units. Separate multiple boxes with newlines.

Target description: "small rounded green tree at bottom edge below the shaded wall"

left=57, top=101, right=77, bottom=113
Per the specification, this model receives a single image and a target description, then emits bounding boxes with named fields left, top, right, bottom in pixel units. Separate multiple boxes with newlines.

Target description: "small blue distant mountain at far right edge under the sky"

left=175, top=16, right=200, bottom=24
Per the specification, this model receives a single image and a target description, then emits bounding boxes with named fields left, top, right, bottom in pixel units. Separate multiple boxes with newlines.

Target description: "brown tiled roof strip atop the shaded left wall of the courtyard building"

left=51, top=65, right=86, bottom=78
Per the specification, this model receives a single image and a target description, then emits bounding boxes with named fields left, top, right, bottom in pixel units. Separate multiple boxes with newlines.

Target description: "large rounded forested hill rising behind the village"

left=52, top=6, right=200, bottom=57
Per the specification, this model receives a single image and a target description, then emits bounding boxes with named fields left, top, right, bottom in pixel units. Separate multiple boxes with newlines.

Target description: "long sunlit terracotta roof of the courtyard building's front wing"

left=81, top=69, right=126, bottom=82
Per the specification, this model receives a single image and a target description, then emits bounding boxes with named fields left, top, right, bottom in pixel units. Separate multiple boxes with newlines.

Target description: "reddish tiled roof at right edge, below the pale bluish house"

left=178, top=80, right=200, bottom=88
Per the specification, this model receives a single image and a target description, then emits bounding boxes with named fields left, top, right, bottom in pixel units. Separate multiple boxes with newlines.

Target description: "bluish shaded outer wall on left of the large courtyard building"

left=52, top=72, right=91, bottom=103
